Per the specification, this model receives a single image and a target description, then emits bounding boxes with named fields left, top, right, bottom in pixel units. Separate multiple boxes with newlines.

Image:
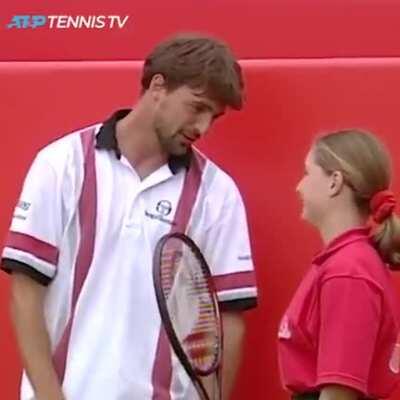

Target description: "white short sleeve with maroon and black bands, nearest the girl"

left=200, top=184, right=257, bottom=311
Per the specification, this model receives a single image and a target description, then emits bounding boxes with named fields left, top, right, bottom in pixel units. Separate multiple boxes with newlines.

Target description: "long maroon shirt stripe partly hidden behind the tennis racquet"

left=151, top=152, right=206, bottom=400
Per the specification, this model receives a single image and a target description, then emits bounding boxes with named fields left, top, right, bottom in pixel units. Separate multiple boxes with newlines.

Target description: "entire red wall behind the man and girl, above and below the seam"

left=0, top=0, right=400, bottom=400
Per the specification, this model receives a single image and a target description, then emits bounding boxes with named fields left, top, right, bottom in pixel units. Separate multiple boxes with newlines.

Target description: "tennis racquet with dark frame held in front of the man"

left=153, top=233, right=223, bottom=400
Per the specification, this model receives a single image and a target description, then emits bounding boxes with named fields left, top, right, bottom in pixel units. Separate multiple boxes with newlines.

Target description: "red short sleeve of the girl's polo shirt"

left=317, top=277, right=381, bottom=395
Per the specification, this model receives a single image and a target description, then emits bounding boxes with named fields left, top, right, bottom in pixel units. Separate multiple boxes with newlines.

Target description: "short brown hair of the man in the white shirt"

left=142, top=34, right=243, bottom=110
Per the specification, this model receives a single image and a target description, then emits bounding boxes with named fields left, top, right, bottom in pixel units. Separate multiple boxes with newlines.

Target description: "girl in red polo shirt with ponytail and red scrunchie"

left=278, top=130, right=400, bottom=400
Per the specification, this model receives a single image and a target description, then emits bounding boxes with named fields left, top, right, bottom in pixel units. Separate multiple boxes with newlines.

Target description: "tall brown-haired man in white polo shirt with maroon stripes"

left=2, top=35, right=256, bottom=400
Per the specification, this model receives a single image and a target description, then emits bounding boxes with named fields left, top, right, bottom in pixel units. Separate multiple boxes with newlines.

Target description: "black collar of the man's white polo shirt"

left=96, top=109, right=192, bottom=174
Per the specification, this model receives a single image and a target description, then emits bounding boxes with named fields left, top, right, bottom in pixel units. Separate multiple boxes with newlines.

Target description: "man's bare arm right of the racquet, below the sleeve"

left=221, top=311, right=246, bottom=400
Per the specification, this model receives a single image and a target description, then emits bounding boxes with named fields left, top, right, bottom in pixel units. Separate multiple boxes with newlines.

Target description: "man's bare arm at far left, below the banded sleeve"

left=11, top=272, right=65, bottom=400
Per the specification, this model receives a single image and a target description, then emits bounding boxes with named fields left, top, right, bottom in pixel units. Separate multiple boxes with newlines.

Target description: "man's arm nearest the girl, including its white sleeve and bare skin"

left=199, top=175, right=257, bottom=400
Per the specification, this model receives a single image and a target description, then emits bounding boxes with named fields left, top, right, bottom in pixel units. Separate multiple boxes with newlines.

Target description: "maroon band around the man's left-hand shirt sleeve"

left=5, top=231, right=58, bottom=268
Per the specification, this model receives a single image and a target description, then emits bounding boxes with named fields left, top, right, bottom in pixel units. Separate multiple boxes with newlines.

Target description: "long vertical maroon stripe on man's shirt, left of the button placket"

left=53, top=129, right=97, bottom=382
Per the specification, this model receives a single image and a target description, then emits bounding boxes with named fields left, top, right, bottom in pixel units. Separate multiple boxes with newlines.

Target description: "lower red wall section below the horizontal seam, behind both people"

left=0, top=59, right=400, bottom=400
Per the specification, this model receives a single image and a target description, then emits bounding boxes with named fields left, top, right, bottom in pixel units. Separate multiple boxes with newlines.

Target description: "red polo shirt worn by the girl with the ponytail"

left=278, top=228, right=400, bottom=398
